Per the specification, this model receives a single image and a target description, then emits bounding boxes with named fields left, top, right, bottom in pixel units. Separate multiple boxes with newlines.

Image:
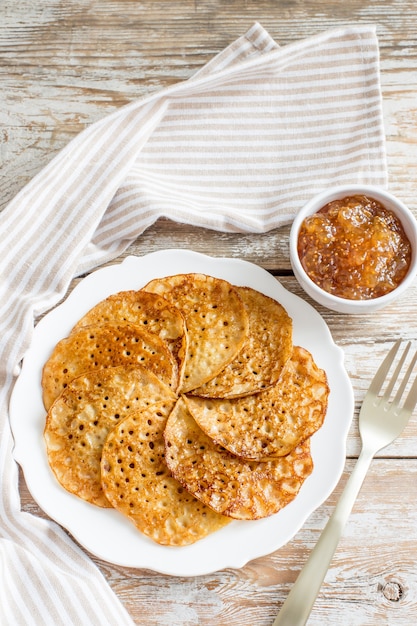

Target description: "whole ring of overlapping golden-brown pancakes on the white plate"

left=42, top=273, right=329, bottom=546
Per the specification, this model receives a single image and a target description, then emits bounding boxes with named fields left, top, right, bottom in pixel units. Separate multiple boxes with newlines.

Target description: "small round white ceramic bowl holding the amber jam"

left=290, top=185, right=417, bottom=313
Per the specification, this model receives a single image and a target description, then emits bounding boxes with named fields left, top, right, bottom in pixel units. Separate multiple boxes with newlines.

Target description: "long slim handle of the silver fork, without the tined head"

left=273, top=448, right=373, bottom=626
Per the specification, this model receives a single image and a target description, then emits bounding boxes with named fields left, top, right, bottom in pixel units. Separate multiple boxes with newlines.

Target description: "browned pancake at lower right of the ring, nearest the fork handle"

left=164, top=399, right=313, bottom=520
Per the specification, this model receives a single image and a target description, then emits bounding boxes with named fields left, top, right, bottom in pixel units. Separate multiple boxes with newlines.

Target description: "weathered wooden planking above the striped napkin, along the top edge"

left=0, top=0, right=417, bottom=208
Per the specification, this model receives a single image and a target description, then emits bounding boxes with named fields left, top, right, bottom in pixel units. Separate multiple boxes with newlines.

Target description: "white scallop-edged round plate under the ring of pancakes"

left=10, top=250, right=354, bottom=576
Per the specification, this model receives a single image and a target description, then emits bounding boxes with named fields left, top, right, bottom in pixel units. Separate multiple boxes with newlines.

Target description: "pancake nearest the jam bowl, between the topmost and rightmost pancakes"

left=192, top=287, right=292, bottom=398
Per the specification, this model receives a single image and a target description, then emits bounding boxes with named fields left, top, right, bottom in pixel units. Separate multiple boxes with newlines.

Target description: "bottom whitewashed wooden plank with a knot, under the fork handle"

left=21, top=459, right=417, bottom=626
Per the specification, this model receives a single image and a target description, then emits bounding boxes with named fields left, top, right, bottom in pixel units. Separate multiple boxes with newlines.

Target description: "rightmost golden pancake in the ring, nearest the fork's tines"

left=185, top=346, right=329, bottom=460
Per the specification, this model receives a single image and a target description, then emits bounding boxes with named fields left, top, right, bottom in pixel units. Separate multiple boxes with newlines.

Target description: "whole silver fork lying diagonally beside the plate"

left=273, top=340, right=417, bottom=626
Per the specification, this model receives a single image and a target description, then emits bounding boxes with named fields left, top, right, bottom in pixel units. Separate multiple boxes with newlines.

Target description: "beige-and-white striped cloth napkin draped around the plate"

left=0, top=24, right=387, bottom=626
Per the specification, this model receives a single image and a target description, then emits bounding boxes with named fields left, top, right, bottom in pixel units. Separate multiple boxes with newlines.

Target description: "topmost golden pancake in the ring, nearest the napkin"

left=144, top=274, right=248, bottom=392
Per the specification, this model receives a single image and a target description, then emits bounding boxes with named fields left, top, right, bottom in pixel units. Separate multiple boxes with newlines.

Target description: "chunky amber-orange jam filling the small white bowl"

left=297, top=194, right=412, bottom=300
